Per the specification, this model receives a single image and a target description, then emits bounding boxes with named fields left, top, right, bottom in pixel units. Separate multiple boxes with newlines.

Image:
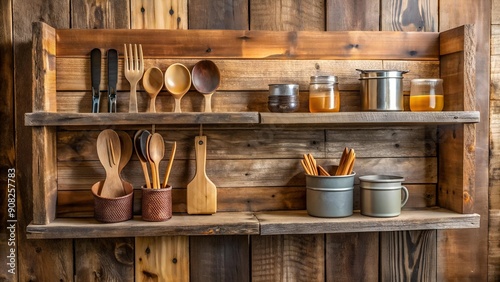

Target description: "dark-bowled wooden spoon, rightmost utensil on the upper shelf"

left=192, top=60, right=220, bottom=112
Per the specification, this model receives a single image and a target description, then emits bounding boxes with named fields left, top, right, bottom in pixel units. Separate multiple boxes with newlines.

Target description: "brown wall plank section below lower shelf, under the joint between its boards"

left=251, top=234, right=325, bottom=281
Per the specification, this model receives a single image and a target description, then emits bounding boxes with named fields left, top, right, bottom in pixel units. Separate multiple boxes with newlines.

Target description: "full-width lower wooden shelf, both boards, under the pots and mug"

left=27, top=208, right=480, bottom=239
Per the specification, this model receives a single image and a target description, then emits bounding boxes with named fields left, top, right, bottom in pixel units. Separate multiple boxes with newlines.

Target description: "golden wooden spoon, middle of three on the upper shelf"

left=165, top=63, right=191, bottom=113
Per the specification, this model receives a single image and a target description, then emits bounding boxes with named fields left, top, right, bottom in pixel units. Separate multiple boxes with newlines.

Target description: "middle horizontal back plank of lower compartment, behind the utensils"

left=57, top=156, right=438, bottom=191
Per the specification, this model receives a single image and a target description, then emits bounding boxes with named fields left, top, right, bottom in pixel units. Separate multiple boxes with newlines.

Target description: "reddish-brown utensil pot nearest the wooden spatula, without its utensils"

left=142, top=185, right=172, bottom=221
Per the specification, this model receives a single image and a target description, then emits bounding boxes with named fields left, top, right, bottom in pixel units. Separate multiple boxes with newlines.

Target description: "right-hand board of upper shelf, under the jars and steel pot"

left=260, top=111, right=480, bottom=125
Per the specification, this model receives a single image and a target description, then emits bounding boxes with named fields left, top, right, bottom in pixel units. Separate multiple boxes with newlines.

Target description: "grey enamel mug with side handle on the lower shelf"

left=359, top=175, right=409, bottom=217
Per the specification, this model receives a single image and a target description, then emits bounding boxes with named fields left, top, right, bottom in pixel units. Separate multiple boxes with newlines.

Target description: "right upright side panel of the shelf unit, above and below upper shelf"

left=438, top=25, right=476, bottom=213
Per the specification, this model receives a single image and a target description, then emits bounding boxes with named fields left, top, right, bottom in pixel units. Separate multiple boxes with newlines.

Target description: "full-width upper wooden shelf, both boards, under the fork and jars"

left=25, top=111, right=480, bottom=126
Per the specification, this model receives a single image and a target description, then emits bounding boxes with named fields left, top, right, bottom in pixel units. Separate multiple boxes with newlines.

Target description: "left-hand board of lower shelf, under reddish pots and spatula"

left=26, top=212, right=259, bottom=239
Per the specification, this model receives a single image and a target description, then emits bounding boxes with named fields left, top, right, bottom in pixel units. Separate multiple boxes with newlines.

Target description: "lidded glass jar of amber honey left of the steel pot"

left=309, top=75, right=340, bottom=113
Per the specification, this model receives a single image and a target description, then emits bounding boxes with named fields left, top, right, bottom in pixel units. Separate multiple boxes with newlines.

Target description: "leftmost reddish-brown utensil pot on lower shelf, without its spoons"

left=92, top=180, right=134, bottom=223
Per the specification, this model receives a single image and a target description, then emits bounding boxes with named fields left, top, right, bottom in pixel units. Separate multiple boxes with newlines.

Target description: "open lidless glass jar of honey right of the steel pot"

left=410, top=78, right=444, bottom=112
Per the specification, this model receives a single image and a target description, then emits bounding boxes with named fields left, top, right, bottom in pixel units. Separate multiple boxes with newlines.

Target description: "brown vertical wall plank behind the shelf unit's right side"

left=437, top=0, right=492, bottom=281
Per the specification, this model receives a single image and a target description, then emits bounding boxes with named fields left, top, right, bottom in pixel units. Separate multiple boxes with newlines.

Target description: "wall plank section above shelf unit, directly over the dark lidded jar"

left=250, top=0, right=325, bottom=31
